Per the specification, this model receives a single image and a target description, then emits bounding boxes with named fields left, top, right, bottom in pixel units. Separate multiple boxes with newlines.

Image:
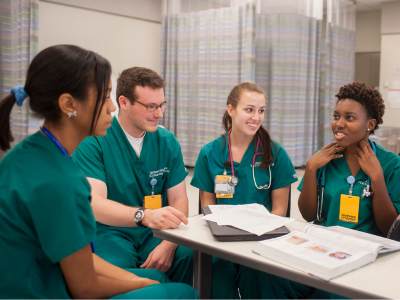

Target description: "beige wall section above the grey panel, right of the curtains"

left=356, top=10, right=381, bottom=52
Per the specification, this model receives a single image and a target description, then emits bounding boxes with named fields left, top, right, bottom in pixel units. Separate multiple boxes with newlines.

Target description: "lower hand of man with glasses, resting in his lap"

left=140, top=241, right=177, bottom=272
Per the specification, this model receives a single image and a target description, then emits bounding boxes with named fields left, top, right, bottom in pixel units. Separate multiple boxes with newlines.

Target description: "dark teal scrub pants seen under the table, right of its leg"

left=211, top=257, right=343, bottom=299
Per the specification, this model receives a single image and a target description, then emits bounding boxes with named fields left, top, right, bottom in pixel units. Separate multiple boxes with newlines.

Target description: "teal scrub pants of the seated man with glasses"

left=95, top=228, right=193, bottom=285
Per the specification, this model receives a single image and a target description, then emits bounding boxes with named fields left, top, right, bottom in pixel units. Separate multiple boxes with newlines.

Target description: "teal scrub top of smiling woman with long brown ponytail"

left=191, top=135, right=297, bottom=210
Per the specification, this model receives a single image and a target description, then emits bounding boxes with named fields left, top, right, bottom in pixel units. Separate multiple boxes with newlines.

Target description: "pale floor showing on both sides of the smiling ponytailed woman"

left=186, top=169, right=304, bottom=220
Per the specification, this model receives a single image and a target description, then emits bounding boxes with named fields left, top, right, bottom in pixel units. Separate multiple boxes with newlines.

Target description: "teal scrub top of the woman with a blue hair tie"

left=0, top=131, right=96, bottom=298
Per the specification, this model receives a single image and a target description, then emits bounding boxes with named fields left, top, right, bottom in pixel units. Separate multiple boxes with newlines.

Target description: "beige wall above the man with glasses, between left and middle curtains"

left=39, top=0, right=161, bottom=75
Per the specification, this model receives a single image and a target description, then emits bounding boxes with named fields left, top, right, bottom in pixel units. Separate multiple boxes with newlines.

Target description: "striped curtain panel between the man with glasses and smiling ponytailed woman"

left=162, top=4, right=255, bottom=166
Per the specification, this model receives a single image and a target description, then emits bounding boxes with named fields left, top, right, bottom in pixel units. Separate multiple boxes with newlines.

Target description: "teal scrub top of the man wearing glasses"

left=73, top=118, right=187, bottom=234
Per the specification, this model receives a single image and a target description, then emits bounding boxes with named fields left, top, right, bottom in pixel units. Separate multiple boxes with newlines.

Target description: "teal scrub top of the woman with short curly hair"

left=298, top=144, right=400, bottom=235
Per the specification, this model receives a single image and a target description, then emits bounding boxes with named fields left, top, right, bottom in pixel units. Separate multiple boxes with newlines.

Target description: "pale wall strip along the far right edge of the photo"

left=380, top=1, right=400, bottom=127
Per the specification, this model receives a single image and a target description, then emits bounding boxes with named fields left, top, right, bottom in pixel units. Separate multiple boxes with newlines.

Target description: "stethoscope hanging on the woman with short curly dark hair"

left=317, top=140, right=376, bottom=223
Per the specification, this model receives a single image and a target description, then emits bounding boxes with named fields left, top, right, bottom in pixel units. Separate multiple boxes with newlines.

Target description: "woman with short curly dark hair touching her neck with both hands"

left=299, top=82, right=400, bottom=236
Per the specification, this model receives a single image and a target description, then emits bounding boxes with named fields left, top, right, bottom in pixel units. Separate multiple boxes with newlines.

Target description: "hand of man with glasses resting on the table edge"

left=142, top=206, right=188, bottom=229
